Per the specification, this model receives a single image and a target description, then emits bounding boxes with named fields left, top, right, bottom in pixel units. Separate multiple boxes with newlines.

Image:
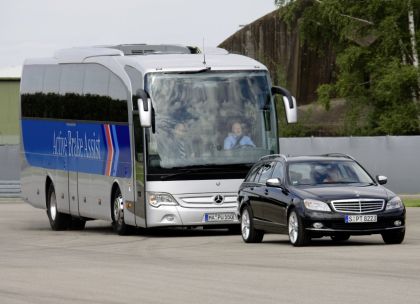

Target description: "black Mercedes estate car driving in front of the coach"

left=238, top=154, right=406, bottom=246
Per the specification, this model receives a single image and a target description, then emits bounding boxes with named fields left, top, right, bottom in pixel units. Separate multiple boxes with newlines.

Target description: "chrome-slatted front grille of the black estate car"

left=331, top=199, right=385, bottom=213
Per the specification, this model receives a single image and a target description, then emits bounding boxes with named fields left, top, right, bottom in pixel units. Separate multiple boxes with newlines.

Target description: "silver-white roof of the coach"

left=25, top=45, right=267, bottom=74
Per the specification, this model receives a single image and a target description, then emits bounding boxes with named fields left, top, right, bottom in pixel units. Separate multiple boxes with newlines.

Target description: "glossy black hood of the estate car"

left=295, top=185, right=395, bottom=201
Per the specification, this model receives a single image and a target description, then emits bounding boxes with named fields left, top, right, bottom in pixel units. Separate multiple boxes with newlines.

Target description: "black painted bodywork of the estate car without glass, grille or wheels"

left=238, top=160, right=406, bottom=237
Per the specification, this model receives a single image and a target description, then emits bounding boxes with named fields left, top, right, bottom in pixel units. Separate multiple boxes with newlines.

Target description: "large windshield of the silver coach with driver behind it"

left=146, top=71, right=278, bottom=173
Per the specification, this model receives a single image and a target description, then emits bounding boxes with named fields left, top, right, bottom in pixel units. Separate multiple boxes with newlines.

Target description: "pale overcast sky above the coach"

left=0, top=0, right=276, bottom=68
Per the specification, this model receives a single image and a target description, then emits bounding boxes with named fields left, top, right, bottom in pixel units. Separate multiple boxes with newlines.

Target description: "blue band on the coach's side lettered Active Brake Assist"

left=22, top=119, right=131, bottom=178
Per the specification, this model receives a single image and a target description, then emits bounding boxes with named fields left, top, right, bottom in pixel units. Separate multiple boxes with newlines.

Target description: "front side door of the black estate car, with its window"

left=264, top=162, right=291, bottom=226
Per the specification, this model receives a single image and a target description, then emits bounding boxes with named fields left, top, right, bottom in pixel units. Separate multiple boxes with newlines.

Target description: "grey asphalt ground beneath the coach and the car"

left=0, top=201, right=420, bottom=304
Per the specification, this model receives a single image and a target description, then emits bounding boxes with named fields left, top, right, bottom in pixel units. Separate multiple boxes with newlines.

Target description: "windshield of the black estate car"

left=287, top=160, right=374, bottom=186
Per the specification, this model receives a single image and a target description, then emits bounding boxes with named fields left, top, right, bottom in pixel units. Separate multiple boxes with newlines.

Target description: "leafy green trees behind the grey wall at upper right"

left=276, top=0, right=420, bottom=135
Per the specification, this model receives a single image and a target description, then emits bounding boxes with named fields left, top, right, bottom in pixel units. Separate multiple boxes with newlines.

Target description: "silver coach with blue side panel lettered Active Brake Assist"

left=21, top=44, right=296, bottom=234
